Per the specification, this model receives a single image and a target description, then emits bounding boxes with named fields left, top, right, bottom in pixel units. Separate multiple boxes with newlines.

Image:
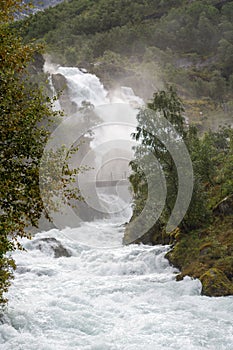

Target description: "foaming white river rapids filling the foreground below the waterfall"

left=0, top=65, right=233, bottom=350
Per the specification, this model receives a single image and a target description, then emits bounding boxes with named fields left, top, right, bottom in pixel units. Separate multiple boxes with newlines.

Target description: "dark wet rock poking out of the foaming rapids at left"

left=32, top=237, right=72, bottom=258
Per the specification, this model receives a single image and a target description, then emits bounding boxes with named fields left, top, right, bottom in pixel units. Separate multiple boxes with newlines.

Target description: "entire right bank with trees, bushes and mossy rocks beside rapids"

left=124, top=88, right=233, bottom=296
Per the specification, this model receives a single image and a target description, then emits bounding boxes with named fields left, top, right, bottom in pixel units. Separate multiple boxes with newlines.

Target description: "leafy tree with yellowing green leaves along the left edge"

left=0, top=0, right=80, bottom=303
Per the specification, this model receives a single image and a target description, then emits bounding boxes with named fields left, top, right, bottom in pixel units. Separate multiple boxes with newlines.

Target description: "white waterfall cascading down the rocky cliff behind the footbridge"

left=44, top=63, right=143, bottom=227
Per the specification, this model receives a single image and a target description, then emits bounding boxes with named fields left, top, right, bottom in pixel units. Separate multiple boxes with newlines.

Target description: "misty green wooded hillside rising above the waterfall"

left=17, top=0, right=233, bottom=127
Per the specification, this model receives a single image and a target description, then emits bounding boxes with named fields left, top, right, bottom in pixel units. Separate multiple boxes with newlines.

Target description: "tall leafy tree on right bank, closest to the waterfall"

left=130, top=87, right=186, bottom=230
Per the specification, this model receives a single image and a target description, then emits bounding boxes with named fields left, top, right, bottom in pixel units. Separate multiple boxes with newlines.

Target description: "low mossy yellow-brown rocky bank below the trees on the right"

left=126, top=215, right=233, bottom=296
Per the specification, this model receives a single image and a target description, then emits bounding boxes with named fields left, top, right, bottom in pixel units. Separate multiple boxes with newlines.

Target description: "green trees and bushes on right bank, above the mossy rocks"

left=130, top=88, right=233, bottom=237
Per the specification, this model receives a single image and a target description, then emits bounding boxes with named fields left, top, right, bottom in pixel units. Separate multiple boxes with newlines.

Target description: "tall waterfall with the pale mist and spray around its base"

left=44, top=61, right=143, bottom=227
